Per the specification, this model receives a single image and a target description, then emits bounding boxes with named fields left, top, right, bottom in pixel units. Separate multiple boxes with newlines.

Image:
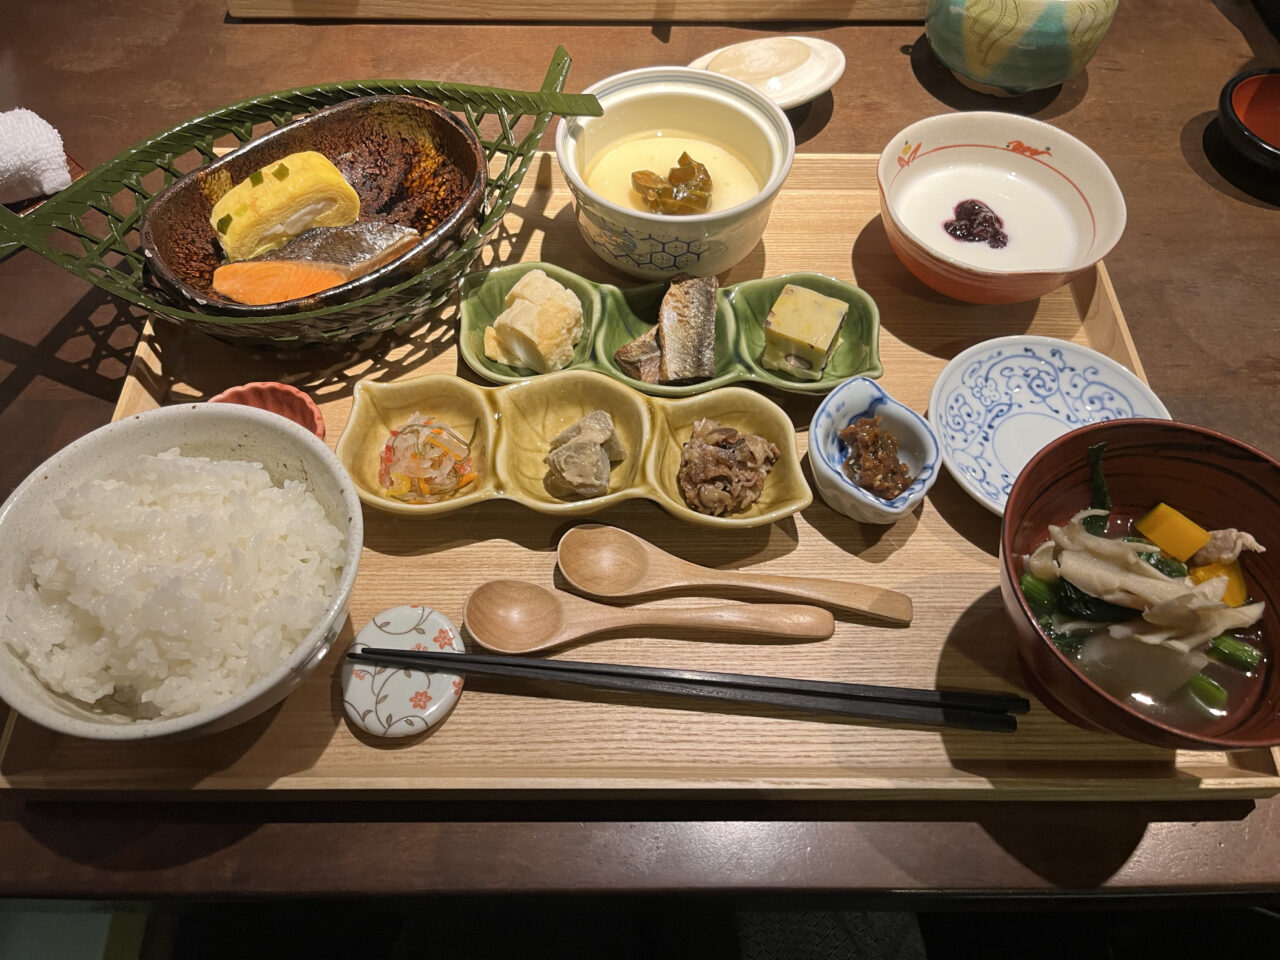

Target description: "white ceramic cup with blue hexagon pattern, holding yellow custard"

left=556, top=67, right=795, bottom=280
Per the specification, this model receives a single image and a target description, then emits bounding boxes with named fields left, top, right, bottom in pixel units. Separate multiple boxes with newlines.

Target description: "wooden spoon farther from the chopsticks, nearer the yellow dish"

left=557, top=524, right=911, bottom=623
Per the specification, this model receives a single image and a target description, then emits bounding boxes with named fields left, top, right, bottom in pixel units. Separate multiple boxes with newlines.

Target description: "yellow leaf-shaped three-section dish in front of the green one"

left=338, top=370, right=813, bottom=529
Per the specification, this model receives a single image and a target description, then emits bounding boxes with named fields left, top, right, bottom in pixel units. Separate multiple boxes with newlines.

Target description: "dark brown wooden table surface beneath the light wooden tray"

left=0, top=0, right=1280, bottom=897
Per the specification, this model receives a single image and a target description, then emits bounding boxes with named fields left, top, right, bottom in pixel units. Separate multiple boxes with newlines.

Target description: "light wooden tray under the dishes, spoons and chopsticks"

left=0, top=155, right=1280, bottom=800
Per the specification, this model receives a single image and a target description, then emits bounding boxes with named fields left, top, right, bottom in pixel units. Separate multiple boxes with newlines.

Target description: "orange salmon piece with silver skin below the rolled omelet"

left=214, top=220, right=421, bottom=306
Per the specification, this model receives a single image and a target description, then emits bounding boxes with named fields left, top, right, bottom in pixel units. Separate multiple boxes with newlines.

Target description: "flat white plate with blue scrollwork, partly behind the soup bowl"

left=929, top=335, right=1171, bottom=516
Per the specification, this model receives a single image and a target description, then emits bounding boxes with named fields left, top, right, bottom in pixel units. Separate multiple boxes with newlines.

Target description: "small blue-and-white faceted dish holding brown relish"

left=809, top=376, right=938, bottom=524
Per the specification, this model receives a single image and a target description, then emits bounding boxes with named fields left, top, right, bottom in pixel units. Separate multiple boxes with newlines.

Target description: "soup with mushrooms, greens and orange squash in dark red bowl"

left=1019, top=444, right=1267, bottom=732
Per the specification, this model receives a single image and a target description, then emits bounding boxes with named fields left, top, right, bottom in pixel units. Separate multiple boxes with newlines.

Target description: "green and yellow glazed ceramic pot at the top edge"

left=924, top=0, right=1120, bottom=96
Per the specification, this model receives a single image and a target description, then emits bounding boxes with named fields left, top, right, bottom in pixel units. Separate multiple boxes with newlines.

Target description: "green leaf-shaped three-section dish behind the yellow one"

left=458, top=262, right=884, bottom=397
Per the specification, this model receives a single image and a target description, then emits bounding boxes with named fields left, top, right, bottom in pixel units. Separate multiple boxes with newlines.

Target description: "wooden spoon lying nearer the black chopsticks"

left=462, top=580, right=836, bottom=653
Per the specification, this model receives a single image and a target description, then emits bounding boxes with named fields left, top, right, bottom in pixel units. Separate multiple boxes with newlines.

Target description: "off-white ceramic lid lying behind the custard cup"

left=689, top=37, right=845, bottom=110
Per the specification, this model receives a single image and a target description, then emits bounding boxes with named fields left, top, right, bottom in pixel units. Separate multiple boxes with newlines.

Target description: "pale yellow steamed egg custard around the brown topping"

left=585, top=131, right=760, bottom=214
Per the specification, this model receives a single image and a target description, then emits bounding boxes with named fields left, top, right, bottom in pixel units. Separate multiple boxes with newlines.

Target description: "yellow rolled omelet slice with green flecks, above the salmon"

left=209, top=150, right=360, bottom=260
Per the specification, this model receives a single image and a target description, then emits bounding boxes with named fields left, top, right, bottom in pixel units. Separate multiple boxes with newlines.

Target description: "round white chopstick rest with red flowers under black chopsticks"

left=342, top=605, right=466, bottom=737
